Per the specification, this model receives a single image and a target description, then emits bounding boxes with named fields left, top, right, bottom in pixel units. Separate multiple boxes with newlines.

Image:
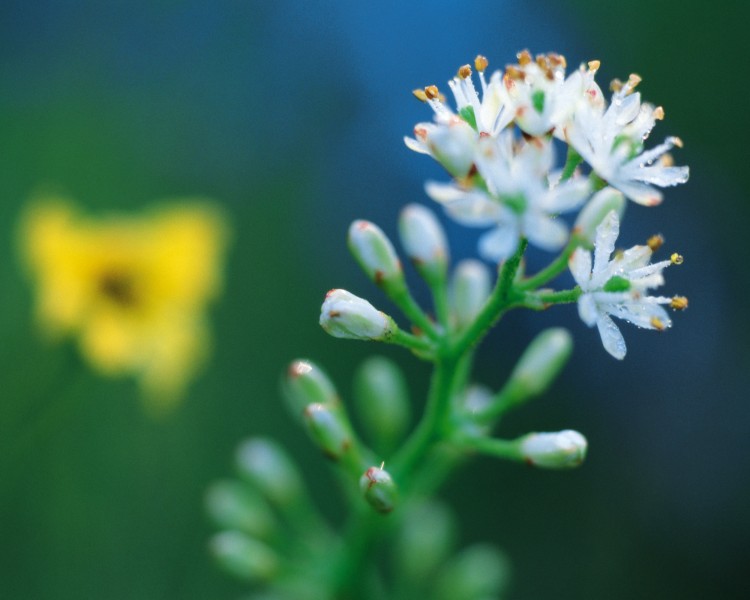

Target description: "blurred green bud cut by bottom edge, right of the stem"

left=436, top=544, right=510, bottom=600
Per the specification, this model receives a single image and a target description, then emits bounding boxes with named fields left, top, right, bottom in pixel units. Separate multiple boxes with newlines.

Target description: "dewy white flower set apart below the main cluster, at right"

left=569, top=211, right=673, bottom=359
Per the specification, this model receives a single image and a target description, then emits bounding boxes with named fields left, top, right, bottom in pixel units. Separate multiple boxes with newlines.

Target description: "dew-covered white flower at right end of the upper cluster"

left=564, top=75, right=689, bottom=206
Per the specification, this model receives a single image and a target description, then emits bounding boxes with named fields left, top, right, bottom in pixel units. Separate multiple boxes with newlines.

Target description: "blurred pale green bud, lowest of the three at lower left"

left=209, top=531, right=279, bottom=582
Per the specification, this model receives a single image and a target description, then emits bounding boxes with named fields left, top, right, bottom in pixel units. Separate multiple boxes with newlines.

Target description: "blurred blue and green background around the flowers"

left=0, top=0, right=750, bottom=600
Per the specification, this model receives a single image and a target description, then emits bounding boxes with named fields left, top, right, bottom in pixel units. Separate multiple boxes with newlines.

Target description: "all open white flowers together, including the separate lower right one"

left=412, top=51, right=689, bottom=358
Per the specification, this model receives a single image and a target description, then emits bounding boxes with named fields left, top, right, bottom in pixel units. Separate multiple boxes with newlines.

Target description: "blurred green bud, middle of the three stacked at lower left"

left=206, top=481, right=275, bottom=537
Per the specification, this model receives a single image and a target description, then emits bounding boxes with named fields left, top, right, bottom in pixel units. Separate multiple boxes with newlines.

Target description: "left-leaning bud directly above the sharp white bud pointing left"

left=348, top=220, right=406, bottom=294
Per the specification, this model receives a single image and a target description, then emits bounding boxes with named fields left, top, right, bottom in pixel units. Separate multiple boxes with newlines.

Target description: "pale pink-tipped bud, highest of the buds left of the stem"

left=399, top=204, right=448, bottom=283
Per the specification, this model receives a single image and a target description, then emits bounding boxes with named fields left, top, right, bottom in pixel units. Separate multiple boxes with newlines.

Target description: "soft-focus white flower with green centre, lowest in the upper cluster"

left=426, top=136, right=589, bottom=261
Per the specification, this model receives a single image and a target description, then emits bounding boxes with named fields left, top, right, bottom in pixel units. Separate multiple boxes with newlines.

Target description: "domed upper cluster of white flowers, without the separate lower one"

left=405, top=51, right=688, bottom=261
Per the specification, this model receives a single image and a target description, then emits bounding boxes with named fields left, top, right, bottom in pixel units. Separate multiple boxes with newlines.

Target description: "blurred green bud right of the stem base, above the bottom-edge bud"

left=394, top=500, right=457, bottom=583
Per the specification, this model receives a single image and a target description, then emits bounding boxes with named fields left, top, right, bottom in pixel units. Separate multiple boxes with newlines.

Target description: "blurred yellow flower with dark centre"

left=20, top=198, right=232, bottom=411
